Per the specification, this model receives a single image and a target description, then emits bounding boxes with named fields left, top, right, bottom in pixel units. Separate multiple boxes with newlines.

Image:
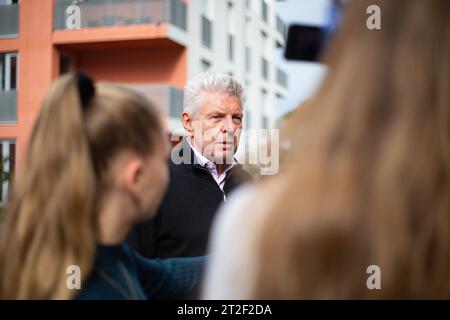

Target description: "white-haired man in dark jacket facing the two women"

left=129, top=72, right=251, bottom=258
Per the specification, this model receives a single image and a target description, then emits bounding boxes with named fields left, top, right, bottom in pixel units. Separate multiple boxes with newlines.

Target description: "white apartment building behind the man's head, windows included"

left=166, top=0, right=288, bottom=133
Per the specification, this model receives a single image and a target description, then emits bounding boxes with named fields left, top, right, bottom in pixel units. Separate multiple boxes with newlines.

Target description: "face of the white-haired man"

left=183, top=92, right=243, bottom=164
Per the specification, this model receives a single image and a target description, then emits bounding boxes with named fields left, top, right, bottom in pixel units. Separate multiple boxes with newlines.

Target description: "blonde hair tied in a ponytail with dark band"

left=0, top=75, right=162, bottom=299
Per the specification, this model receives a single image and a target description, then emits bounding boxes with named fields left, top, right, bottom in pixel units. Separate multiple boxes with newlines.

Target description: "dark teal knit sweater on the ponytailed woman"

left=76, top=244, right=206, bottom=300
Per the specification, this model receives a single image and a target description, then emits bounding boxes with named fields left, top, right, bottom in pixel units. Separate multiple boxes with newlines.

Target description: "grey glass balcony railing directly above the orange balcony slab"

left=53, top=0, right=186, bottom=30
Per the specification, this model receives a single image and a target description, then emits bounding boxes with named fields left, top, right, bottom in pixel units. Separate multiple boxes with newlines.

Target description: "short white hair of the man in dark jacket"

left=183, top=71, right=244, bottom=114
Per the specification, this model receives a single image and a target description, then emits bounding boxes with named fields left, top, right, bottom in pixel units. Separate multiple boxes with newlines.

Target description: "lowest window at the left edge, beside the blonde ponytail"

left=0, top=140, right=16, bottom=207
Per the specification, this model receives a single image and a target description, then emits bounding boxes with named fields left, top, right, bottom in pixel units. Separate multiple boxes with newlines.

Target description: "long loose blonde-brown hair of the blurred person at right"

left=252, top=0, right=450, bottom=299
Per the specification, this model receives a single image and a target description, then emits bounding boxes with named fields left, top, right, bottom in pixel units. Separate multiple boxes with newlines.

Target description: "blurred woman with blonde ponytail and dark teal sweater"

left=0, top=75, right=203, bottom=299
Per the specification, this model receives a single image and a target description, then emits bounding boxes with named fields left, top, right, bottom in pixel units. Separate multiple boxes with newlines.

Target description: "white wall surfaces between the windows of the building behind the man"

left=188, top=0, right=287, bottom=132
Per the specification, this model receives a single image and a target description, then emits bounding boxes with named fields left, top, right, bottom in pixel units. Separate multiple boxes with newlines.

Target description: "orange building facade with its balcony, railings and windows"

left=0, top=0, right=187, bottom=205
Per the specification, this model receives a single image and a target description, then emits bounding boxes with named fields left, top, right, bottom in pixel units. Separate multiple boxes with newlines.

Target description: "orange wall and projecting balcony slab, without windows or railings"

left=0, top=0, right=187, bottom=174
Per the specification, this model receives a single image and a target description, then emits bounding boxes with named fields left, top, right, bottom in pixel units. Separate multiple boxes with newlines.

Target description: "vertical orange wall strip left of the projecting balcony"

left=0, top=1, right=58, bottom=169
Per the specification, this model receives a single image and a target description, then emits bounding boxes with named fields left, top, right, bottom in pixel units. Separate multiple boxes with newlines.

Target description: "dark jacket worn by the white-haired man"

left=128, top=140, right=252, bottom=259
